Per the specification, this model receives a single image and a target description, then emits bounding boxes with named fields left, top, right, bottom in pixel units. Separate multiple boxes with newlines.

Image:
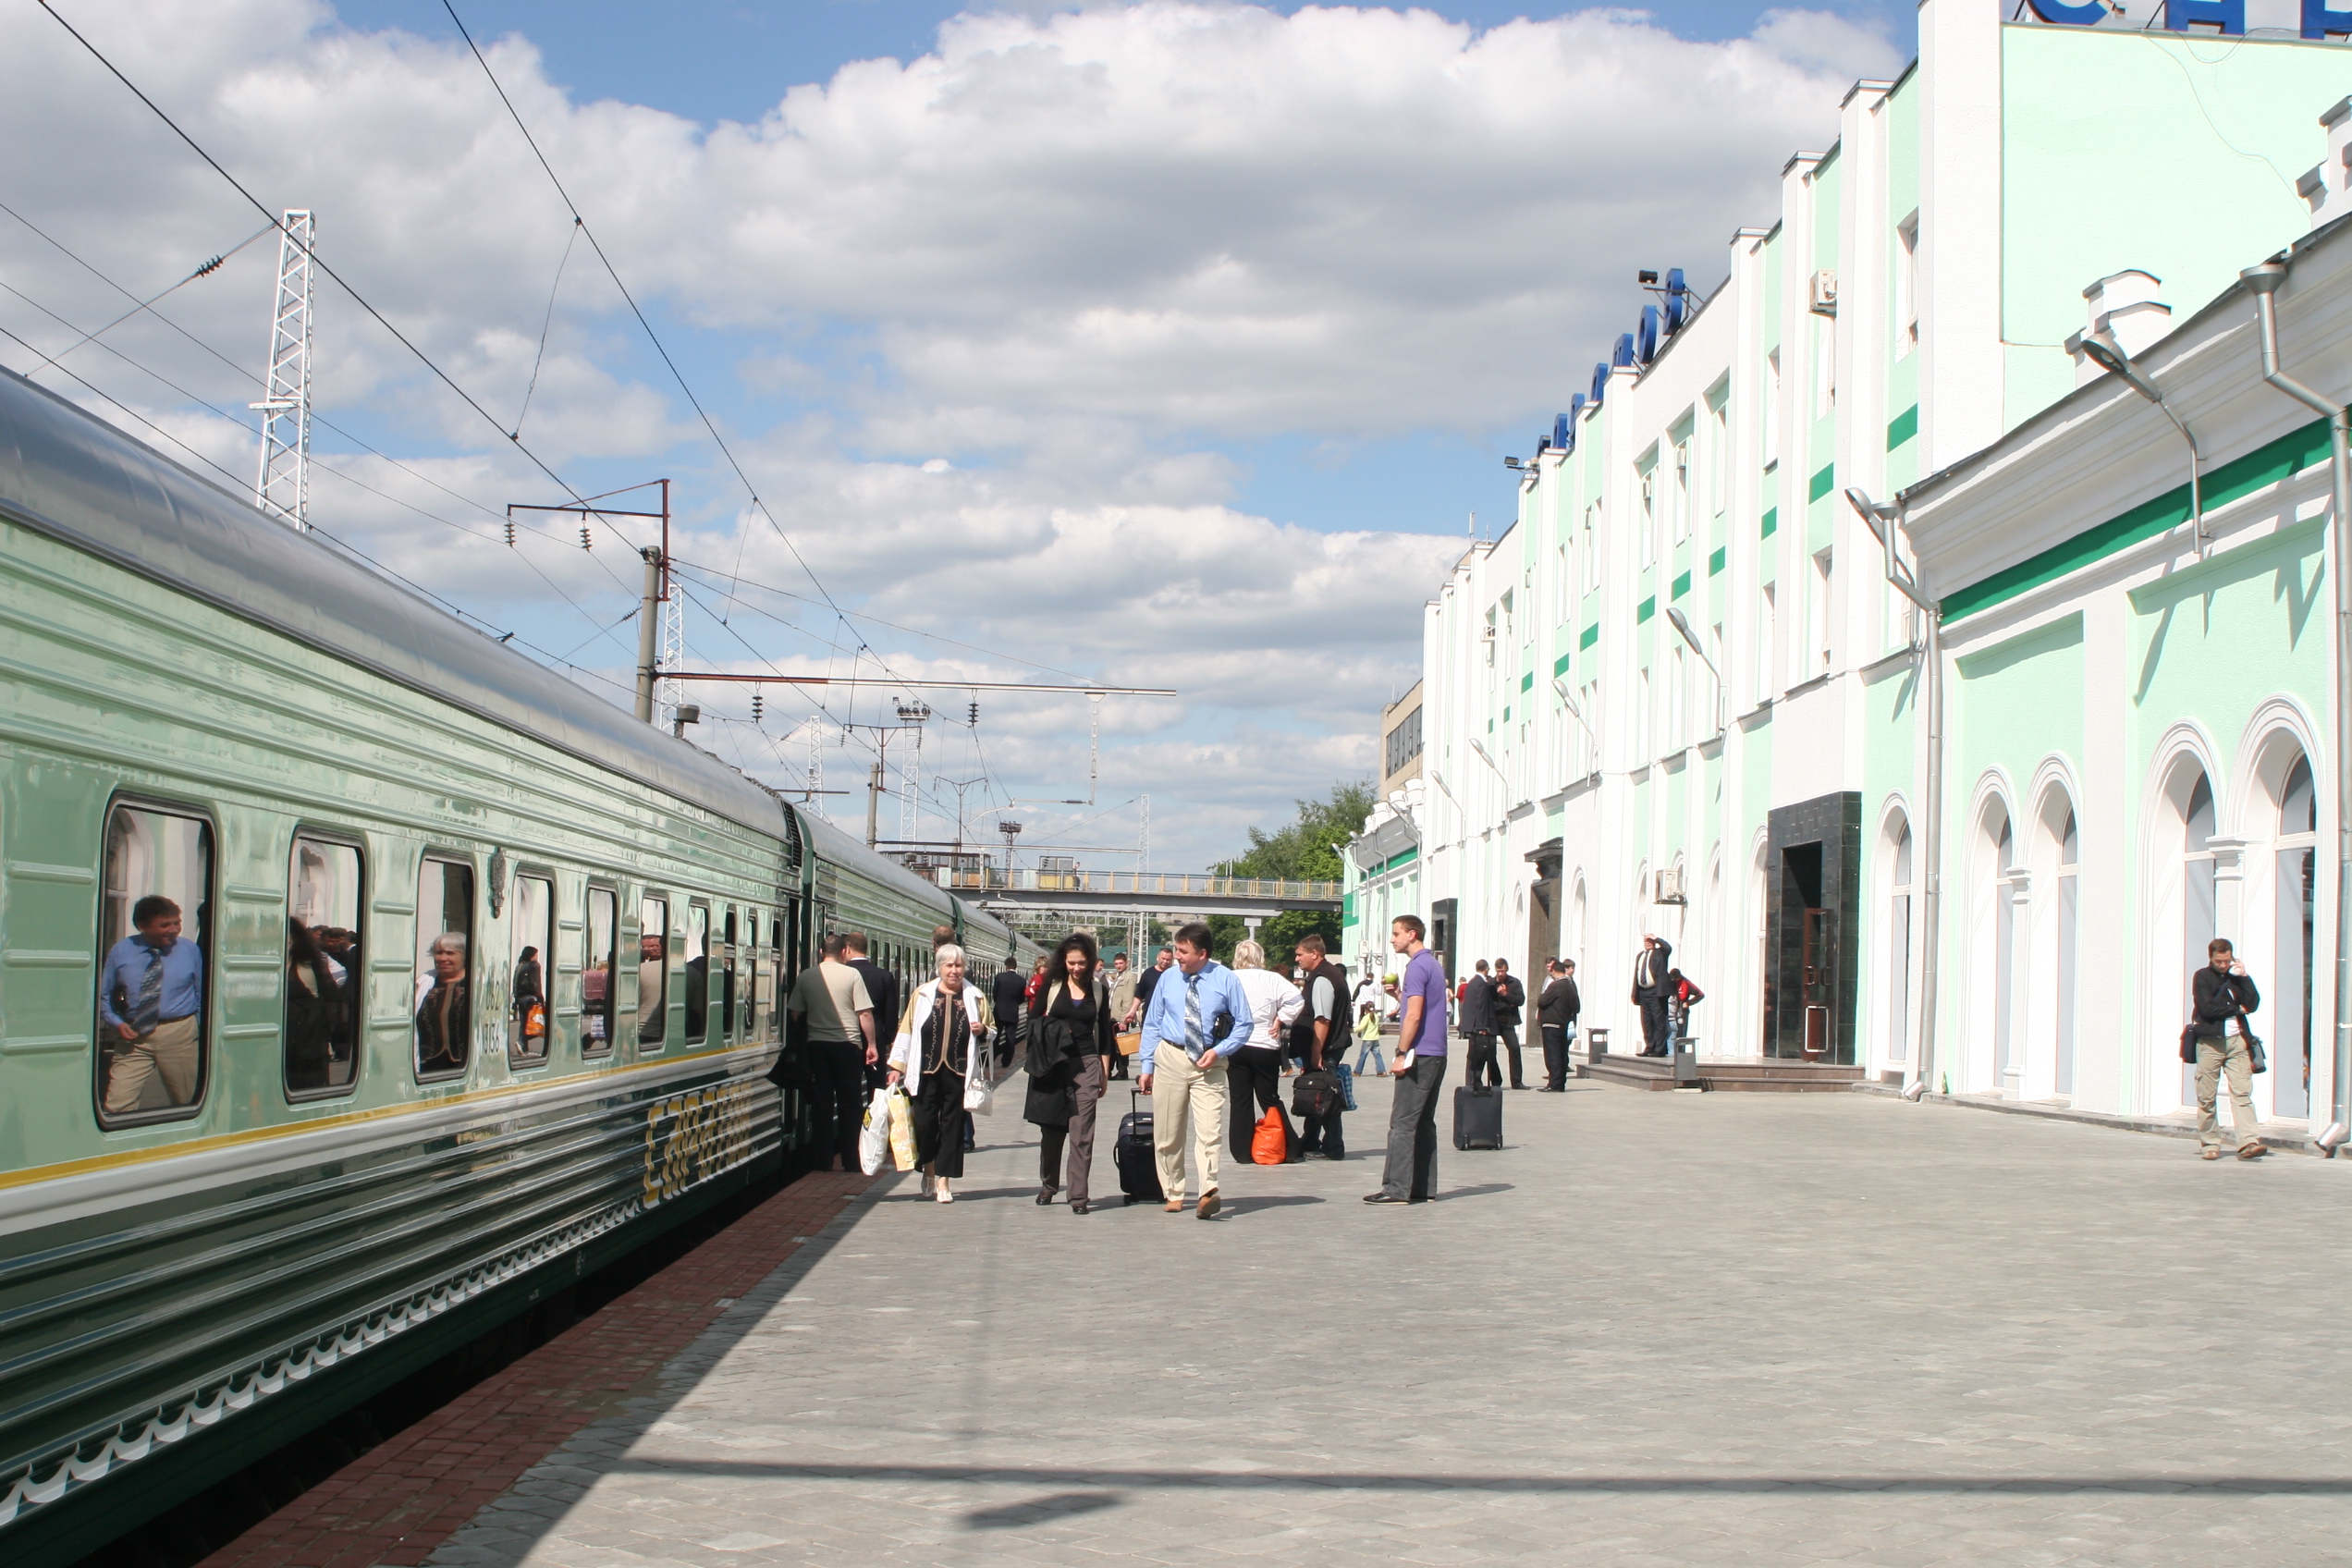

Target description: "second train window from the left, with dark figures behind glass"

left=285, top=835, right=367, bottom=1100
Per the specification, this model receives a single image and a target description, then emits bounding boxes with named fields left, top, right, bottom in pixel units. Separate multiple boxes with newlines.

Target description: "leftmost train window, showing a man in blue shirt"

left=96, top=806, right=212, bottom=1126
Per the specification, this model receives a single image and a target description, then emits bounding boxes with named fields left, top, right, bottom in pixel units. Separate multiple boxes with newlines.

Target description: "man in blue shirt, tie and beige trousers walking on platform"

left=1136, top=919, right=1249, bottom=1220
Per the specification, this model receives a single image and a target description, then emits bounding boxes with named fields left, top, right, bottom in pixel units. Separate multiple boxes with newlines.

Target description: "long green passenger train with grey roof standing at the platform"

left=0, top=372, right=1033, bottom=1563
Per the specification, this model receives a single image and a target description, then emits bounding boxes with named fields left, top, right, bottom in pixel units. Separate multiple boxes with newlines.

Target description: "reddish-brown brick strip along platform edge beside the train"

left=200, top=1170, right=873, bottom=1568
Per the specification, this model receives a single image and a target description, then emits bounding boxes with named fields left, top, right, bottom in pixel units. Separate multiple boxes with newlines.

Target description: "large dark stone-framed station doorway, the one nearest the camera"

left=1764, top=790, right=1863, bottom=1065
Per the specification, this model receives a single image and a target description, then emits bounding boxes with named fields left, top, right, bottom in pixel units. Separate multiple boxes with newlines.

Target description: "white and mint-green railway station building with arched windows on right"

left=1348, top=0, right=2352, bottom=1129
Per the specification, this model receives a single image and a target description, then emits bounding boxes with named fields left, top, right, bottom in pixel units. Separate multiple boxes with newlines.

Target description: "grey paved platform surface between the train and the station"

left=428, top=1086, right=2352, bottom=1568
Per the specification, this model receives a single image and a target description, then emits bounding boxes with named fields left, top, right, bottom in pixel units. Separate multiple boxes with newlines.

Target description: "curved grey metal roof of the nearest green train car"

left=0, top=369, right=790, bottom=849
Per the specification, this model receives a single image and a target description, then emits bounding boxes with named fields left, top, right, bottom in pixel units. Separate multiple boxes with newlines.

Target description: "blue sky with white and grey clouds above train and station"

left=0, top=0, right=1912, bottom=870
